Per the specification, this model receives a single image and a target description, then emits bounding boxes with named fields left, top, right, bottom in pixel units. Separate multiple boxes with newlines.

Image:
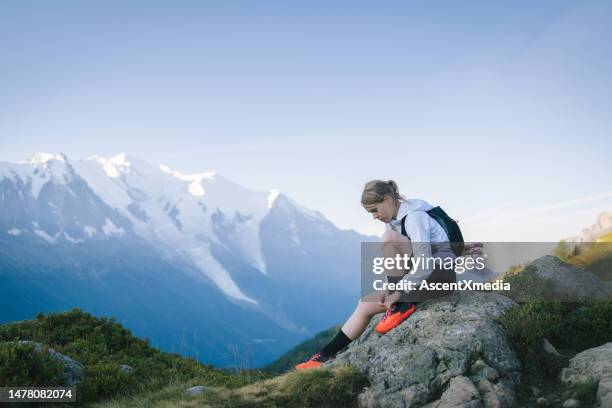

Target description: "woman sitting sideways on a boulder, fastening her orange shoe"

left=295, top=180, right=456, bottom=370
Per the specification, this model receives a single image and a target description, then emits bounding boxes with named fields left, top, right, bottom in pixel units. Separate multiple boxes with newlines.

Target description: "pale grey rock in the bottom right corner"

left=561, top=343, right=612, bottom=408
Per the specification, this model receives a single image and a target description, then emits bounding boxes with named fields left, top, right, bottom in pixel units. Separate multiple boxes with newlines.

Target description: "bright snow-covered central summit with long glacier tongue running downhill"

left=74, top=154, right=269, bottom=303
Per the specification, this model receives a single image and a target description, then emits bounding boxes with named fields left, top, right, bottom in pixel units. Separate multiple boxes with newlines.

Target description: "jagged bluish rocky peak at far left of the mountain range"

left=0, top=153, right=132, bottom=244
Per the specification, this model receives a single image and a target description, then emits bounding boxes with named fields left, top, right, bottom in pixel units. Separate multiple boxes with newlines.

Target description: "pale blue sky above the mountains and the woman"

left=0, top=0, right=612, bottom=241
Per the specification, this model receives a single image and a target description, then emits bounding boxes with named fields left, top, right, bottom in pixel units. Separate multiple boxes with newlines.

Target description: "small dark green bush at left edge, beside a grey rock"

left=0, top=343, right=63, bottom=387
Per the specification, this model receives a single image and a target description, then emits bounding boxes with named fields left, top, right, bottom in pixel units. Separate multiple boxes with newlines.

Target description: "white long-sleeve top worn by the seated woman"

left=385, top=199, right=454, bottom=287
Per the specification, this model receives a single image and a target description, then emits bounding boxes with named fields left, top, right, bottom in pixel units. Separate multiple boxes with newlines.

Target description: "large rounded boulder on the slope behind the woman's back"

left=522, top=255, right=612, bottom=302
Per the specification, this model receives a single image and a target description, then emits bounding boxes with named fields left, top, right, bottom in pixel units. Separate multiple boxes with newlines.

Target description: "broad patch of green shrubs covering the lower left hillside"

left=0, top=309, right=270, bottom=403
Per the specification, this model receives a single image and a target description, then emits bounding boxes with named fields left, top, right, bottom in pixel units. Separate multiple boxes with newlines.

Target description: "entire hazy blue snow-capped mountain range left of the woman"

left=0, top=153, right=365, bottom=362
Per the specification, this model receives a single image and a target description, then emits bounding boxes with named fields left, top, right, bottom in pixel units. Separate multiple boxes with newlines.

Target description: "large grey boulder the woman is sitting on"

left=326, top=292, right=520, bottom=408
